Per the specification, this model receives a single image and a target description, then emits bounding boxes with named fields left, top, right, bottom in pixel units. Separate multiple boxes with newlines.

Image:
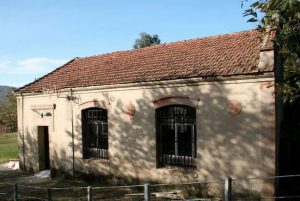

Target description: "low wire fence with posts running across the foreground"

left=0, top=175, right=300, bottom=201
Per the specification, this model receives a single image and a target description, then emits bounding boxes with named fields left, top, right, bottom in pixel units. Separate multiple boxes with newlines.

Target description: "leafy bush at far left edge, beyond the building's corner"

left=0, top=93, right=17, bottom=129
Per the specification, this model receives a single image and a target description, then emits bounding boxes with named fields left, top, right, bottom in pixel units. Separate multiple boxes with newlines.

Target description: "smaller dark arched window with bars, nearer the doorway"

left=81, top=107, right=108, bottom=159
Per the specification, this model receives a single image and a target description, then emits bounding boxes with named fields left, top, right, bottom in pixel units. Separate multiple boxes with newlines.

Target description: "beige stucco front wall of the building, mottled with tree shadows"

left=18, top=76, right=275, bottom=187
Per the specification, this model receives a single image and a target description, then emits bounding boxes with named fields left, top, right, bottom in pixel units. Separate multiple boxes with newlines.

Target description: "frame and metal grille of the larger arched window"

left=155, top=104, right=197, bottom=168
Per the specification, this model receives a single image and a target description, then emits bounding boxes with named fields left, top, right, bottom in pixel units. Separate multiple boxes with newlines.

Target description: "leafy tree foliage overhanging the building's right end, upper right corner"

left=244, top=0, right=300, bottom=103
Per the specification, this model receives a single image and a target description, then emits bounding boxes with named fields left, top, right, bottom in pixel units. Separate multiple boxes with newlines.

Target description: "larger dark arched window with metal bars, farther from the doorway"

left=155, top=105, right=196, bottom=167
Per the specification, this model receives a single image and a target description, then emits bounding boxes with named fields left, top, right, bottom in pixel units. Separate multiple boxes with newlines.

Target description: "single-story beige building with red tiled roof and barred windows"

left=17, top=30, right=280, bottom=193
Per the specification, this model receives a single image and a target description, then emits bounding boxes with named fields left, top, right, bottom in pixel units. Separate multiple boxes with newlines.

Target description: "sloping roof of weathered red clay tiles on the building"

left=18, top=30, right=273, bottom=93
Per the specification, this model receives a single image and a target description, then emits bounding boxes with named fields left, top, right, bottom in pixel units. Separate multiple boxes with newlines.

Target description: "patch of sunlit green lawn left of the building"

left=0, top=133, right=18, bottom=163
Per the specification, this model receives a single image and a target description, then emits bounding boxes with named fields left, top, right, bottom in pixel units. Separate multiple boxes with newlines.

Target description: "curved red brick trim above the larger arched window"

left=153, top=96, right=200, bottom=109
